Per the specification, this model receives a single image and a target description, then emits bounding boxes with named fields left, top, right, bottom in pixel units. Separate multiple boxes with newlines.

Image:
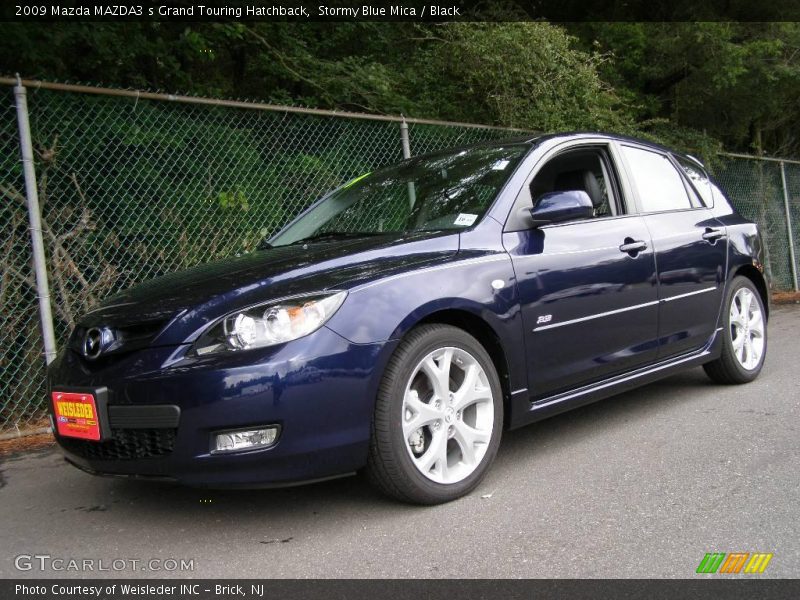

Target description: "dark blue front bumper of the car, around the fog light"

left=48, top=327, right=394, bottom=487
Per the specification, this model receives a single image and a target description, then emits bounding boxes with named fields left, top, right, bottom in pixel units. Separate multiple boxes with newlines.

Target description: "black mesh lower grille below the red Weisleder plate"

left=58, top=429, right=178, bottom=460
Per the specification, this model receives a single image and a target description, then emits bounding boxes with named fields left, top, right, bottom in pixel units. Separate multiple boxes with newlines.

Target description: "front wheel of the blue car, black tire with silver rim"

left=366, top=324, right=503, bottom=504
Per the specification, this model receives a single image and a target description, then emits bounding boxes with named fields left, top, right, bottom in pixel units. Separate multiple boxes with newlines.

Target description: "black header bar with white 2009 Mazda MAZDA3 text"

left=0, top=0, right=800, bottom=23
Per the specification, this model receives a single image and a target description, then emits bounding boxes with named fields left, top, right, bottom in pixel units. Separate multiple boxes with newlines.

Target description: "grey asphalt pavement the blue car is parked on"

left=0, top=306, right=800, bottom=578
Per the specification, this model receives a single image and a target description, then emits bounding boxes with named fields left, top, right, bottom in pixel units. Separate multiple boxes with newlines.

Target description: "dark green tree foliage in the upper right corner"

left=571, top=22, right=800, bottom=156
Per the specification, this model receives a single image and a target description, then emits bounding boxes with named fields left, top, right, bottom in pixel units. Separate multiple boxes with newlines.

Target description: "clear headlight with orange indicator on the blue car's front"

left=193, top=291, right=347, bottom=355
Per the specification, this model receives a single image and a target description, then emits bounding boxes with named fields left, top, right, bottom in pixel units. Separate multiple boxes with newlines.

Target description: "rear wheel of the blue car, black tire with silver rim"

left=703, top=275, right=767, bottom=384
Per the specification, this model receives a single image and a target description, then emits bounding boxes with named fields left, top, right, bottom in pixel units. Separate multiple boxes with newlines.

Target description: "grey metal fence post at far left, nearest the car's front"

left=14, top=76, right=56, bottom=364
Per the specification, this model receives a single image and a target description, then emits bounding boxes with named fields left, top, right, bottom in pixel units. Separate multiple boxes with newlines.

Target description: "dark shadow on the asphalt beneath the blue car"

left=89, top=369, right=713, bottom=516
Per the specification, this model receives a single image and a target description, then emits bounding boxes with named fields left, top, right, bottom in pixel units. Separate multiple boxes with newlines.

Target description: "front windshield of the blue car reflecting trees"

left=271, top=144, right=528, bottom=246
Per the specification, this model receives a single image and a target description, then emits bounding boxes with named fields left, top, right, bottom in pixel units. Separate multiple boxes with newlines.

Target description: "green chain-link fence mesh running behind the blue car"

left=0, top=80, right=800, bottom=435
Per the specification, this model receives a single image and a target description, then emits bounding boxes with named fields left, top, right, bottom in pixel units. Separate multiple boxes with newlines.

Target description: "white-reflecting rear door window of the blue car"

left=622, top=145, right=692, bottom=212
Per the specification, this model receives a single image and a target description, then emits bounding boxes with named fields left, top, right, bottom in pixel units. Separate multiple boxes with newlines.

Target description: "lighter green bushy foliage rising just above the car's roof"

left=418, top=22, right=630, bottom=131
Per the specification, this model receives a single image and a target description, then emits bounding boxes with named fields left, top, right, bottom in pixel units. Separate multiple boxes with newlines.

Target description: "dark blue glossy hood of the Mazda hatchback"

left=79, top=232, right=458, bottom=345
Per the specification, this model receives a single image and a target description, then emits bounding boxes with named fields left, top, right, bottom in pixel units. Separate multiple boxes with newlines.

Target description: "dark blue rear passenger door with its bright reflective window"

left=621, top=143, right=728, bottom=359
